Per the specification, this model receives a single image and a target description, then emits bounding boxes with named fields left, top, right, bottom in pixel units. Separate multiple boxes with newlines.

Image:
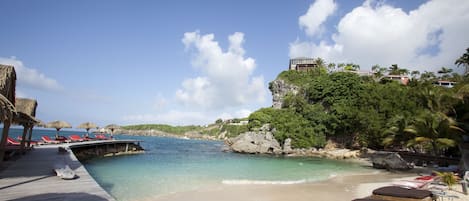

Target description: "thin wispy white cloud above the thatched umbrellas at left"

left=0, top=57, right=63, bottom=91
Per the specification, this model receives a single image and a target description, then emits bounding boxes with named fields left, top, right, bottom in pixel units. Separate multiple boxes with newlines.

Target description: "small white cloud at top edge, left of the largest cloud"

left=298, top=0, right=337, bottom=36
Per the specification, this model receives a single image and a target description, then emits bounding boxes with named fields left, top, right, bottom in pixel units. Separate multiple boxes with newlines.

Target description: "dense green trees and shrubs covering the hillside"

left=248, top=51, right=469, bottom=155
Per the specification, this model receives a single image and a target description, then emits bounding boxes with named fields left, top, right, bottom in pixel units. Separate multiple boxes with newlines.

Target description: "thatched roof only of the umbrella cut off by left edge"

left=0, top=64, right=16, bottom=106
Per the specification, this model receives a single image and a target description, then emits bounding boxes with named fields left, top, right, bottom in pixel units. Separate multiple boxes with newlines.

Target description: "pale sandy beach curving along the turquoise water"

left=152, top=170, right=469, bottom=201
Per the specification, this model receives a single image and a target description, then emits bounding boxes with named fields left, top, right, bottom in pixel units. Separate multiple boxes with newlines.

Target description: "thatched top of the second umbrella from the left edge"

left=13, top=98, right=38, bottom=125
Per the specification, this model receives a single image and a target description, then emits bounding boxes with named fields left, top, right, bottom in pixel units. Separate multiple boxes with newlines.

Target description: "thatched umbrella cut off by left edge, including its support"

left=0, top=64, right=16, bottom=163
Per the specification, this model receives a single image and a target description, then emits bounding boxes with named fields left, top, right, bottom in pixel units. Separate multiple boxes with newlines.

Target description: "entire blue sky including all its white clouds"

left=0, top=0, right=469, bottom=126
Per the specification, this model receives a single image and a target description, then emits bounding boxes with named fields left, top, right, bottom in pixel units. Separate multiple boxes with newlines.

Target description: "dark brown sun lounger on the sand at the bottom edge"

left=371, top=186, right=433, bottom=201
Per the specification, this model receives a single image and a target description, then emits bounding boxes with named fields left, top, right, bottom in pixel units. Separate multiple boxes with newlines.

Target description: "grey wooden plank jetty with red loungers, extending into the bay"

left=0, top=140, right=143, bottom=201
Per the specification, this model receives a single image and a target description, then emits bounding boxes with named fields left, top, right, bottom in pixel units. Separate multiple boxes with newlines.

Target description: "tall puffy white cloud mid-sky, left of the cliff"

left=176, top=32, right=266, bottom=110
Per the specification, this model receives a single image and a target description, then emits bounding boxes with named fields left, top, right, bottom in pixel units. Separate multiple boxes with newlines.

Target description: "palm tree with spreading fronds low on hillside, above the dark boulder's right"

left=406, top=110, right=464, bottom=155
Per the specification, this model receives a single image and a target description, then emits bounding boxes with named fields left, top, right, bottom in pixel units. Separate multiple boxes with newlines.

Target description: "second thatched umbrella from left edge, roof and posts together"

left=13, top=98, right=39, bottom=153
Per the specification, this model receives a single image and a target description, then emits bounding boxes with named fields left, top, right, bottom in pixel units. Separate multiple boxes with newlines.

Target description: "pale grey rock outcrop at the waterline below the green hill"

left=225, top=124, right=282, bottom=154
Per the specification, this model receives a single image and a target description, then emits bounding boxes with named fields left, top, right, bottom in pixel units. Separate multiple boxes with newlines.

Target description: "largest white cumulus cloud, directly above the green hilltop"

left=290, top=0, right=469, bottom=71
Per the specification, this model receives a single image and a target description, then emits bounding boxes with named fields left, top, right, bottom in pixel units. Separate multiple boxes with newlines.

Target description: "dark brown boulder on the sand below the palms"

left=371, top=151, right=413, bottom=170
